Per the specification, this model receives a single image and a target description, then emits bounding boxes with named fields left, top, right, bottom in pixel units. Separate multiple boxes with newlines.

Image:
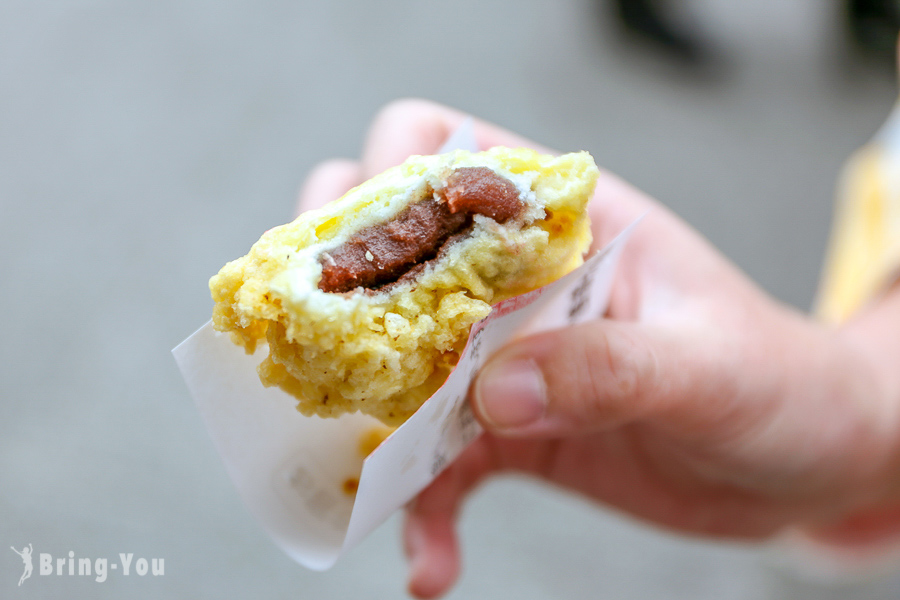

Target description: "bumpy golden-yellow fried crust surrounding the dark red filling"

left=209, top=148, right=599, bottom=425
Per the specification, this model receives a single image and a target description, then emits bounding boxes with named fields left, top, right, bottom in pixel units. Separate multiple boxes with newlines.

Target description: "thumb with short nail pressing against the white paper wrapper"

left=472, top=320, right=737, bottom=436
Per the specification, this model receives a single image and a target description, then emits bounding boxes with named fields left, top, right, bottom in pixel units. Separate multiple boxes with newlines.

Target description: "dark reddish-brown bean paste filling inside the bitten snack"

left=319, top=167, right=525, bottom=293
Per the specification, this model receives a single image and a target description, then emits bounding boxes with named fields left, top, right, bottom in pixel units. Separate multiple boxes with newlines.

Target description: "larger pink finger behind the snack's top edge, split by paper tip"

left=362, top=99, right=550, bottom=178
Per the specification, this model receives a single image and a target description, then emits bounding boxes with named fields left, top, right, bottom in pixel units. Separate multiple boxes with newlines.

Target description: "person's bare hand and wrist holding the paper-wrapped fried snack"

left=299, top=100, right=900, bottom=598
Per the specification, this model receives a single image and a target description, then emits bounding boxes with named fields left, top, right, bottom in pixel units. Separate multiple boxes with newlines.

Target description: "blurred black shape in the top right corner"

left=848, top=0, right=900, bottom=65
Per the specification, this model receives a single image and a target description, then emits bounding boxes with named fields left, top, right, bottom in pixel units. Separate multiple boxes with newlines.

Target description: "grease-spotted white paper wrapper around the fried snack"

left=172, top=122, right=636, bottom=570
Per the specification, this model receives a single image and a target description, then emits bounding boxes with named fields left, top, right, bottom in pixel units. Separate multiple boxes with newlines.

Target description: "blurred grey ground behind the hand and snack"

left=0, top=0, right=900, bottom=600
